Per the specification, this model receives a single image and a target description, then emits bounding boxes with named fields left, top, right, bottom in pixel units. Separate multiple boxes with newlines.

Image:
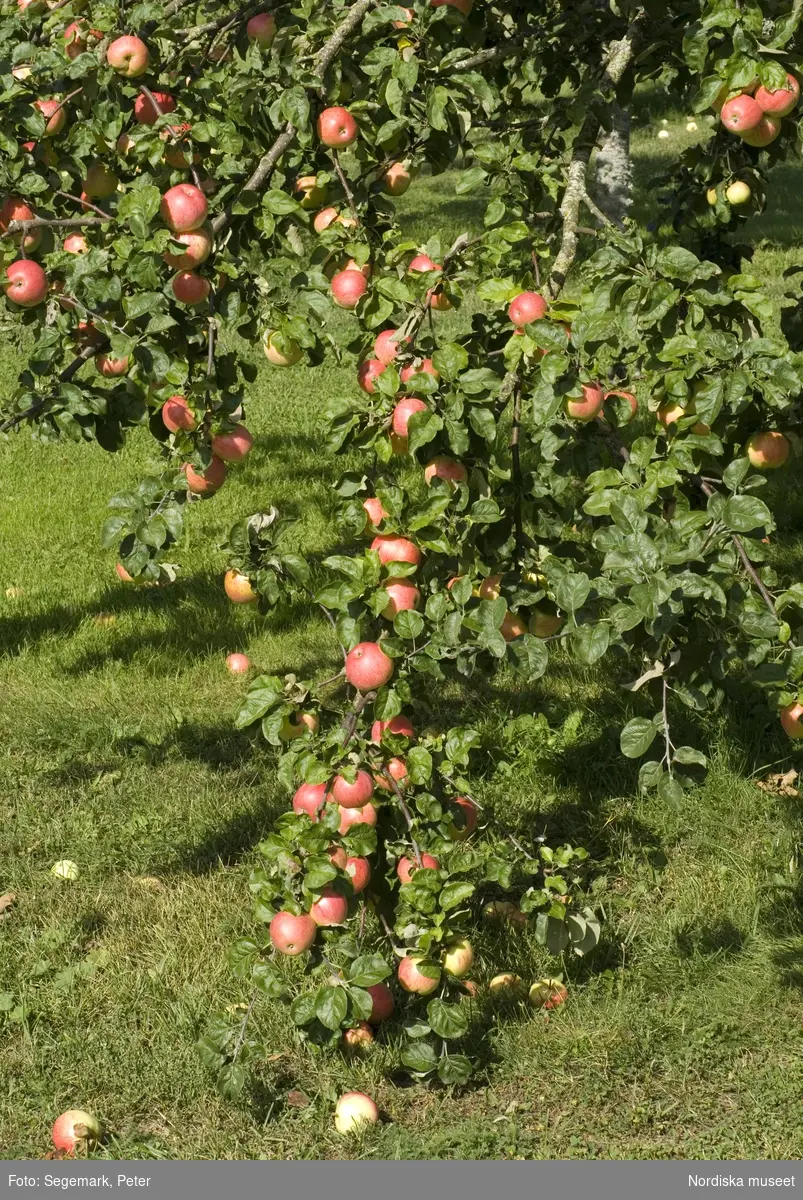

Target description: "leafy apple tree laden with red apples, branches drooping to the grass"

left=0, top=0, right=803, bottom=1094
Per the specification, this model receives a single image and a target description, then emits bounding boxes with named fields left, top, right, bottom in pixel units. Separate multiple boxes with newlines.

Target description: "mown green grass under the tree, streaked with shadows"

left=0, top=113, right=803, bottom=1158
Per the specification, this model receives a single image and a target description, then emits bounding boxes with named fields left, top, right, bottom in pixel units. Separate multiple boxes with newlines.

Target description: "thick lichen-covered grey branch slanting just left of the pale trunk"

left=547, top=10, right=645, bottom=300
